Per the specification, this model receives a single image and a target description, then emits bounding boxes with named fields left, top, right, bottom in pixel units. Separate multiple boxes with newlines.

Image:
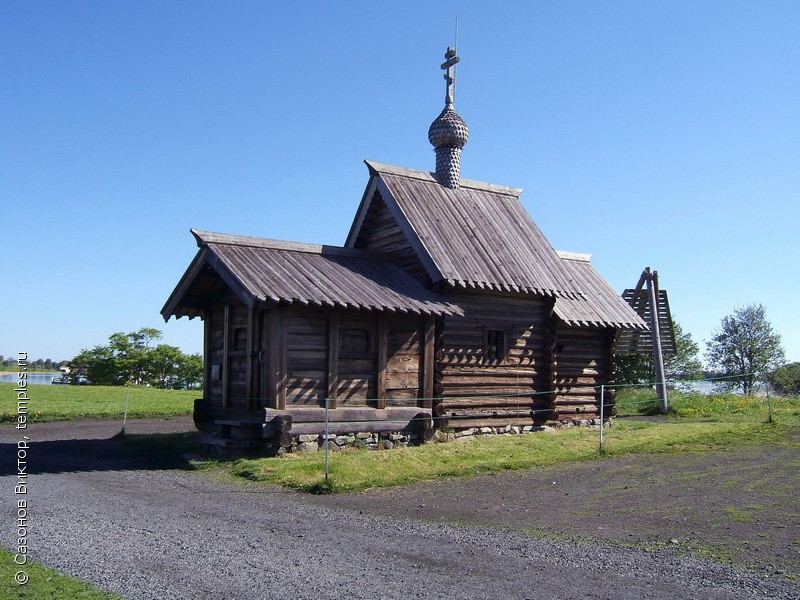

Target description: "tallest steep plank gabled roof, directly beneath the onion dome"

left=345, top=161, right=582, bottom=298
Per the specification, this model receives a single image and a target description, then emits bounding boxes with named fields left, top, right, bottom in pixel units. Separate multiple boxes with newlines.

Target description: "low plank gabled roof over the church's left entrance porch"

left=161, top=229, right=461, bottom=320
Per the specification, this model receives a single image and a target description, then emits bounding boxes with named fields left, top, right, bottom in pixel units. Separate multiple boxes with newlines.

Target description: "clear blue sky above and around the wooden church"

left=0, top=0, right=800, bottom=360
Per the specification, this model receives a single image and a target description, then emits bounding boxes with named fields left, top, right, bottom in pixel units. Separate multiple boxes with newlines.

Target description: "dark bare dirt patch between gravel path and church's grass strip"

left=311, top=444, right=800, bottom=578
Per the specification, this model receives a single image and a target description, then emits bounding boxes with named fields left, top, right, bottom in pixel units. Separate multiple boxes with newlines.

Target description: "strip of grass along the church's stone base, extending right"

left=206, top=394, right=800, bottom=493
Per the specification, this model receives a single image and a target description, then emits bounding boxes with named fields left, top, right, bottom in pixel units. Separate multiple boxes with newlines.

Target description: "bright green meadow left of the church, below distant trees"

left=0, top=383, right=202, bottom=423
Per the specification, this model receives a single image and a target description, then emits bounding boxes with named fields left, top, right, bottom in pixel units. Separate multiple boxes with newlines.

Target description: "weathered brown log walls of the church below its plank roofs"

left=198, top=293, right=614, bottom=429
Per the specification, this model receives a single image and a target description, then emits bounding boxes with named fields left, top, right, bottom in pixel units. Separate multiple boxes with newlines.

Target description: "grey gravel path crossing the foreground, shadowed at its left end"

left=0, top=420, right=800, bottom=600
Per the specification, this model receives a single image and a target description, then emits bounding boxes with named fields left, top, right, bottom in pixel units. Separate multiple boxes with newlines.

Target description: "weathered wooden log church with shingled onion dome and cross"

left=162, top=49, right=647, bottom=449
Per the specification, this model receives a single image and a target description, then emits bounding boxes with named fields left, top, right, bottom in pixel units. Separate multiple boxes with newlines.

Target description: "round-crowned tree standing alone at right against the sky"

left=706, top=304, right=784, bottom=395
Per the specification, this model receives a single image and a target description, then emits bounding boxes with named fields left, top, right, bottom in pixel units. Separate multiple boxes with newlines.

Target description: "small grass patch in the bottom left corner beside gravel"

left=0, top=546, right=121, bottom=600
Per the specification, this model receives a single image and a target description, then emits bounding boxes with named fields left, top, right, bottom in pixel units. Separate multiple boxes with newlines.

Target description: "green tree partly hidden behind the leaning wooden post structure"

left=616, top=319, right=703, bottom=384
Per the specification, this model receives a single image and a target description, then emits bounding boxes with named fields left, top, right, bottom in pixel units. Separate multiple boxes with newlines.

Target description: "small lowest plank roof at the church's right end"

left=555, top=251, right=649, bottom=331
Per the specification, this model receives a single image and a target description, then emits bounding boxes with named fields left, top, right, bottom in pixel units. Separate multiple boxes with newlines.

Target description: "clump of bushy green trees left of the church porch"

left=69, top=327, right=203, bottom=389
